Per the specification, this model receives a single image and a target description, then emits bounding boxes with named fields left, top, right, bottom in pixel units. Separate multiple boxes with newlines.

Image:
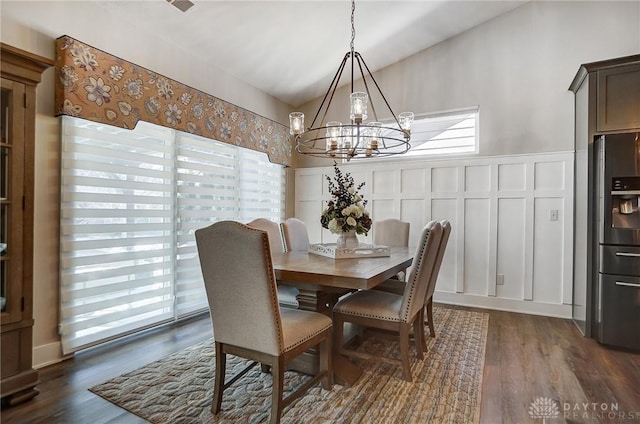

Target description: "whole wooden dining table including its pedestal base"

left=272, top=247, right=414, bottom=387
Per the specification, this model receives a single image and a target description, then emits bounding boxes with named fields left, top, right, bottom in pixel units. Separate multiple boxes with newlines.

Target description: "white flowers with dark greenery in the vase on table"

left=320, top=162, right=372, bottom=235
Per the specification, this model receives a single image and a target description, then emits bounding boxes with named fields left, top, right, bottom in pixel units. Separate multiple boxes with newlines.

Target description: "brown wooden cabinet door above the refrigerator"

left=596, top=64, right=640, bottom=131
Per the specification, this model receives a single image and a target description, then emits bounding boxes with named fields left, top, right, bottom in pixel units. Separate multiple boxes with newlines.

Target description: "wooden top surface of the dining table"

left=272, top=247, right=415, bottom=289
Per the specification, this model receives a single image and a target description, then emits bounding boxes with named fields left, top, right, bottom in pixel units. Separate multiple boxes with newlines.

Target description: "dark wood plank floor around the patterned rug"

left=0, top=308, right=640, bottom=424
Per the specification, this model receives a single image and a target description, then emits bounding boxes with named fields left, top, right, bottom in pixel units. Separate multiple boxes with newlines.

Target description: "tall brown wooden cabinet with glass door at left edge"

left=0, top=43, right=53, bottom=406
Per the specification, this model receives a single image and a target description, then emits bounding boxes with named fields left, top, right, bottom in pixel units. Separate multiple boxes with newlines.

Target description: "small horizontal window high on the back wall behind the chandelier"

left=353, top=107, right=479, bottom=160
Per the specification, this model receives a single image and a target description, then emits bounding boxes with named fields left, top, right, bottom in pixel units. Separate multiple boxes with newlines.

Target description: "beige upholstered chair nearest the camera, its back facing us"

left=195, top=221, right=333, bottom=424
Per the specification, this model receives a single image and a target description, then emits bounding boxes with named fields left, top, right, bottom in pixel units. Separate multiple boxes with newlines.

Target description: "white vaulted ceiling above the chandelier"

left=96, top=0, right=525, bottom=107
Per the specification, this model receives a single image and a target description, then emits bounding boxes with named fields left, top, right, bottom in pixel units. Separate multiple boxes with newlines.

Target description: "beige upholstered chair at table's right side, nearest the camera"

left=333, top=221, right=442, bottom=381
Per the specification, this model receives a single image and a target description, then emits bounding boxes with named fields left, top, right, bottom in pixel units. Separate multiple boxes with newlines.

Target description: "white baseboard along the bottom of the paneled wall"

left=433, top=291, right=571, bottom=319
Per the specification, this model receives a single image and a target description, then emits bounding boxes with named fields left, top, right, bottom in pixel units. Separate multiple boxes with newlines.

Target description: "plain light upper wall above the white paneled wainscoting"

left=295, top=1, right=640, bottom=167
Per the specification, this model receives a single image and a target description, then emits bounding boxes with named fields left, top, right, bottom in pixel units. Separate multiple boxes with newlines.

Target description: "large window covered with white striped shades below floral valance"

left=60, top=116, right=285, bottom=354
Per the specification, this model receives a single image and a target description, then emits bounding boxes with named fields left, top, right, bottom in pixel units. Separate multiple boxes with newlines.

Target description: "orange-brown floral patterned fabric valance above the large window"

left=55, top=35, right=292, bottom=166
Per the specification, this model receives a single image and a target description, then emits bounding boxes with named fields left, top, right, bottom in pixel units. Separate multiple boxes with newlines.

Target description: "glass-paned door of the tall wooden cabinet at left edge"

left=0, top=79, right=25, bottom=325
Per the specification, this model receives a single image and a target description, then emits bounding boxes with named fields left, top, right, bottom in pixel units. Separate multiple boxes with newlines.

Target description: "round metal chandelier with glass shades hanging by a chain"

left=289, top=0, right=414, bottom=161
